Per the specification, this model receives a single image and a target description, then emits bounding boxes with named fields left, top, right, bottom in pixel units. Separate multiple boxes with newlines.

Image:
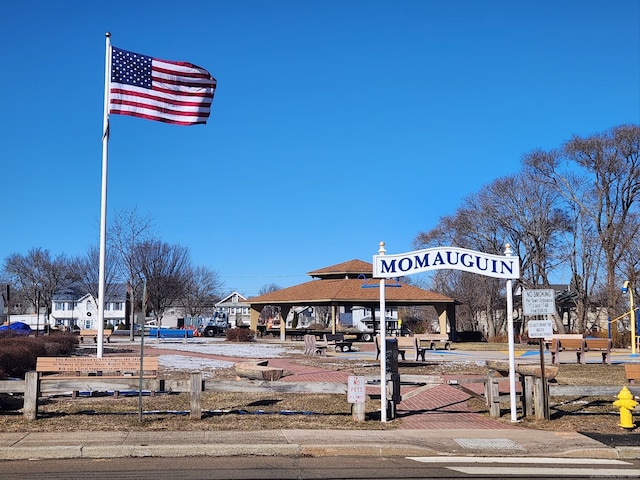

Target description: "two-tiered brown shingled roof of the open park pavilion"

left=248, top=260, right=455, bottom=305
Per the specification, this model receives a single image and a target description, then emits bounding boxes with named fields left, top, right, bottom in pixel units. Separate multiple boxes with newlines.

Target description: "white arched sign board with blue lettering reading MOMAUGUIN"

left=373, top=247, right=520, bottom=279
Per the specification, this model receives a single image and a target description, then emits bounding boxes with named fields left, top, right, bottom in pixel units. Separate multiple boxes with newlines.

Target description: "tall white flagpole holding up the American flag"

left=96, top=32, right=111, bottom=358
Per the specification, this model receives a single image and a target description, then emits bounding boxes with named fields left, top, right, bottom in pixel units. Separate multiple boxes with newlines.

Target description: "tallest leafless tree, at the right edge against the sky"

left=525, top=125, right=640, bottom=340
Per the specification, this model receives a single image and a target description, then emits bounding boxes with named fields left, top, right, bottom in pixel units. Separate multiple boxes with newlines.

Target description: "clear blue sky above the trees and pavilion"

left=0, top=0, right=640, bottom=296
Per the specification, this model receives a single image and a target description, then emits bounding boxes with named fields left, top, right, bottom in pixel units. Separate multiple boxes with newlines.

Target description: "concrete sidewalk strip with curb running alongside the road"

left=0, top=428, right=640, bottom=460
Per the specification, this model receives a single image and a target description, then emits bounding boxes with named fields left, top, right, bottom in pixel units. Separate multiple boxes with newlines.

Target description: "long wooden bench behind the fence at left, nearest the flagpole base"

left=36, top=357, right=158, bottom=398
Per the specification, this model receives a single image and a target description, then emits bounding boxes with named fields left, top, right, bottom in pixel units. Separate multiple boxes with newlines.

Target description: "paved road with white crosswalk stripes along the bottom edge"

left=0, top=457, right=640, bottom=480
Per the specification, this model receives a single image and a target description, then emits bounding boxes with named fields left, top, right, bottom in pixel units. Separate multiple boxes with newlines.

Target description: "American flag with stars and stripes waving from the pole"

left=109, top=47, right=216, bottom=125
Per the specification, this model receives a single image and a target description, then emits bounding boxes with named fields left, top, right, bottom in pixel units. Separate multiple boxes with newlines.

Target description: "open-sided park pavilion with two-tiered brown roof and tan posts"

left=247, top=259, right=456, bottom=340
